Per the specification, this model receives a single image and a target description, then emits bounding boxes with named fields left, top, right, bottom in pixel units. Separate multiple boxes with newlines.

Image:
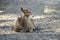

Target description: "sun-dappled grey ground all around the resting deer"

left=0, top=0, right=60, bottom=40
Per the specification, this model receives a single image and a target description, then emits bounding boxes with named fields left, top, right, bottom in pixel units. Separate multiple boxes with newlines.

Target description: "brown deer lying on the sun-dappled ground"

left=14, top=7, right=35, bottom=32
